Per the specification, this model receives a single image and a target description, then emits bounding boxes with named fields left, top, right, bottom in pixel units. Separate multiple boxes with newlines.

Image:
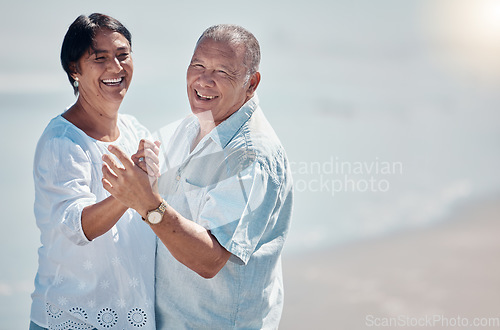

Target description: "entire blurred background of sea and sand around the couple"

left=0, top=0, right=500, bottom=329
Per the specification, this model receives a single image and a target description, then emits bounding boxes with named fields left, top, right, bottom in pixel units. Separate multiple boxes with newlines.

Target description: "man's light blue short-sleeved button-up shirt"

left=156, top=96, right=292, bottom=329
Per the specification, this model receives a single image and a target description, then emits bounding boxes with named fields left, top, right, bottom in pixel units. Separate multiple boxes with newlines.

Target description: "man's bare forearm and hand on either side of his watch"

left=103, top=146, right=231, bottom=278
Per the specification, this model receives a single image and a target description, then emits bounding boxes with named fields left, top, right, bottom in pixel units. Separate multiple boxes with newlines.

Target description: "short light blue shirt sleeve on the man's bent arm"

left=200, top=160, right=280, bottom=264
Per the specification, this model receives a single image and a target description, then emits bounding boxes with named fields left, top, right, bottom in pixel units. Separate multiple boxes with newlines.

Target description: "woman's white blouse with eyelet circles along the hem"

left=31, top=115, right=156, bottom=329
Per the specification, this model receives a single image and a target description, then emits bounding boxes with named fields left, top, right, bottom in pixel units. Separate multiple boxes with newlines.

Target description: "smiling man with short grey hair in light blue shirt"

left=103, top=25, right=292, bottom=329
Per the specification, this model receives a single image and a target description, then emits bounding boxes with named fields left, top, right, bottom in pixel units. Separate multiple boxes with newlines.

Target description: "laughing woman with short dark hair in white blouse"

left=30, top=14, right=158, bottom=329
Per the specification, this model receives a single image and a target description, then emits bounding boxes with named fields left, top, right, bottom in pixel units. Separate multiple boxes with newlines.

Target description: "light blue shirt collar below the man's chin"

left=208, top=94, right=259, bottom=148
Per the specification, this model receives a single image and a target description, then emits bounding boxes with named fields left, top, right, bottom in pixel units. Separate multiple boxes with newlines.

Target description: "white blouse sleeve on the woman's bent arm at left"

left=34, top=138, right=96, bottom=245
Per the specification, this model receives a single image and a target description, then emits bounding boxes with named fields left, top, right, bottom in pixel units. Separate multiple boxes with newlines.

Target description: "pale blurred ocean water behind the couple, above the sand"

left=0, top=0, right=500, bottom=329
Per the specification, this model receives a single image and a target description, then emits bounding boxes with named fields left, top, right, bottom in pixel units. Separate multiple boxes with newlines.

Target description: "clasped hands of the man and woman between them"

left=102, top=139, right=162, bottom=217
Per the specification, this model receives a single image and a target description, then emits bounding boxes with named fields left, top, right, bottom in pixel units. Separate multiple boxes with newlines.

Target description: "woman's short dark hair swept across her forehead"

left=61, top=13, right=132, bottom=95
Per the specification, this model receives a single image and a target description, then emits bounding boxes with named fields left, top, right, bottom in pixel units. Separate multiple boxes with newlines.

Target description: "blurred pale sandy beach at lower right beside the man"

left=280, top=199, right=500, bottom=330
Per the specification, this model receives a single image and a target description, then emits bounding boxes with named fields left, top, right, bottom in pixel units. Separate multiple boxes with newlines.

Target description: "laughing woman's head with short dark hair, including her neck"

left=61, top=19, right=134, bottom=142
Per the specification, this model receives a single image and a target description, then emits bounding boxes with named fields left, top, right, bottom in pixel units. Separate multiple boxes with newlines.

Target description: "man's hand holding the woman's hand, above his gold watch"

left=102, top=143, right=161, bottom=217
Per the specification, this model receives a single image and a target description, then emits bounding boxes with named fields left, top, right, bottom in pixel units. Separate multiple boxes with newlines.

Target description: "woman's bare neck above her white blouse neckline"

left=63, top=97, right=120, bottom=142
